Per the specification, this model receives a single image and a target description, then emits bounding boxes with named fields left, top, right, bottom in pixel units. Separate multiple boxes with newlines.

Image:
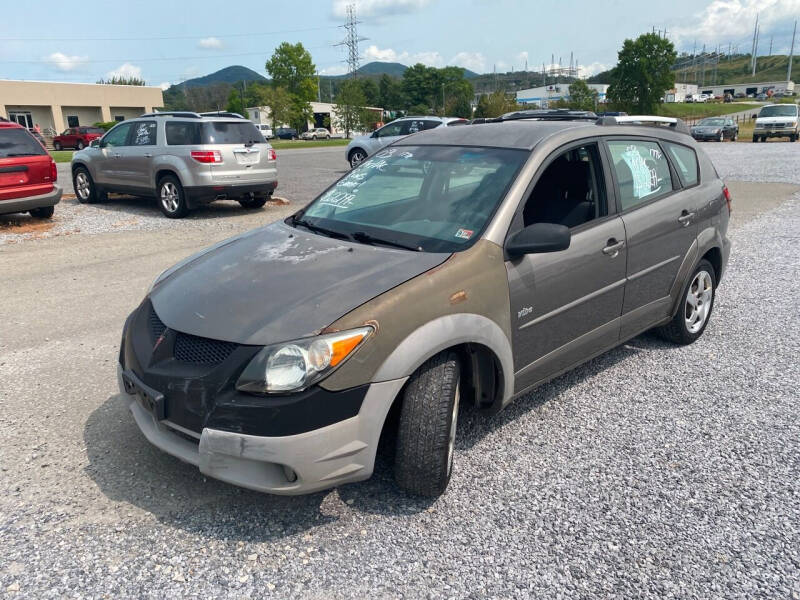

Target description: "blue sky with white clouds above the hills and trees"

left=0, top=0, right=800, bottom=85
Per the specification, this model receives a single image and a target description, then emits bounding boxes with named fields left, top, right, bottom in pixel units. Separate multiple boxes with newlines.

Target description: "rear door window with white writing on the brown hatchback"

left=608, top=140, right=672, bottom=210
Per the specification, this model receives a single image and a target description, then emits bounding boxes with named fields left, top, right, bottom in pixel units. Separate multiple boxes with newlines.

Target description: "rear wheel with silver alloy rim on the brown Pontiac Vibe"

left=657, top=260, right=717, bottom=345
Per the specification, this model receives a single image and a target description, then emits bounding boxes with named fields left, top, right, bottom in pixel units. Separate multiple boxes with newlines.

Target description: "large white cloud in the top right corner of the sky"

left=670, top=0, right=800, bottom=47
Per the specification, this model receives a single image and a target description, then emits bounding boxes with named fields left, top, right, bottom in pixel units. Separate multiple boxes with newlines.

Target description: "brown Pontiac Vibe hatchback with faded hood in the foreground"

left=118, top=111, right=731, bottom=496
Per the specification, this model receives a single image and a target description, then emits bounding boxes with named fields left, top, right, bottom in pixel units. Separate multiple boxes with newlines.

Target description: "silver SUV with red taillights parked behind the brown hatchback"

left=72, top=112, right=278, bottom=219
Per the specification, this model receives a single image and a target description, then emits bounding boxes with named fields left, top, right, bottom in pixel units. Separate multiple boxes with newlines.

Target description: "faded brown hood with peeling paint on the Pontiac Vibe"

left=150, top=222, right=450, bottom=345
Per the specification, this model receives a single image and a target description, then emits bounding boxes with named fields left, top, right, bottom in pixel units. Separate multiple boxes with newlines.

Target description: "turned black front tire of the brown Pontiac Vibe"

left=394, top=352, right=461, bottom=496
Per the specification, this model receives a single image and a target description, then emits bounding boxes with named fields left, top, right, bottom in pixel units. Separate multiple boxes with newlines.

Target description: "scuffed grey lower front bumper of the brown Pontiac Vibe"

left=117, top=365, right=406, bottom=495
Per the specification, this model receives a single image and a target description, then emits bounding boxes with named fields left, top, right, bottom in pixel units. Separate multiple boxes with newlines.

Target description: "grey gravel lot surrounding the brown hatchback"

left=0, top=144, right=800, bottom=599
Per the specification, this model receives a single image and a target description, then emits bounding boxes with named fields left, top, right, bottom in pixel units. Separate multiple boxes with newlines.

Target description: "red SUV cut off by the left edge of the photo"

left=0, top=118, right=61, bottom=219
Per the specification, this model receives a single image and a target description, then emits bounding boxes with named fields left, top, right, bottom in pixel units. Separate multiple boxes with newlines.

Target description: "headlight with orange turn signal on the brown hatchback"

left=236, top=326, right=374, bottom=394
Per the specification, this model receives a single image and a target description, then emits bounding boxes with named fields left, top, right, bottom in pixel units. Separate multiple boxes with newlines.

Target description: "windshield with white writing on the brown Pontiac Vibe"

left=295, top=146, right=528, bottom=252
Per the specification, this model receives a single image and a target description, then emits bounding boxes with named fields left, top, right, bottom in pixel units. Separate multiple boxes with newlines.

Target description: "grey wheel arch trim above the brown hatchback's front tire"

left=374, top=313, right=514, bottom=406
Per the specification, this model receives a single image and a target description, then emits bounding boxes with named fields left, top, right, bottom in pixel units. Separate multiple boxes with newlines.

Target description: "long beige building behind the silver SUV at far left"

left=0, top=80, right=164, bottom=133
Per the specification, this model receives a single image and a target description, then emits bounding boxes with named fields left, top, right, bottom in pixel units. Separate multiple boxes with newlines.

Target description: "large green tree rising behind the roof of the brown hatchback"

left=608, top=33, right=677, bottom=114
